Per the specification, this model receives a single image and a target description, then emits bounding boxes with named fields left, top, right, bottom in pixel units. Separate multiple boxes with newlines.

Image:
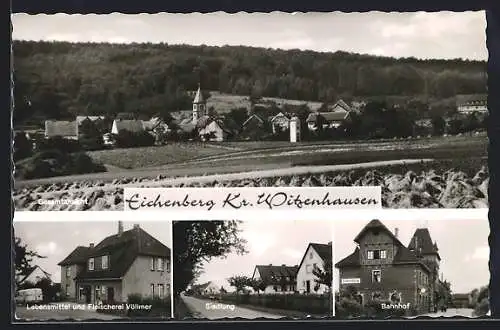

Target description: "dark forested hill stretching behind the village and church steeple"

left=13, top=41, right=486, bottom=122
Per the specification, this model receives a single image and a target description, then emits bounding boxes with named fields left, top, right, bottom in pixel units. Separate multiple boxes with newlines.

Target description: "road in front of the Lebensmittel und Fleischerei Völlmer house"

left=15, top=303, right=120, bottom=321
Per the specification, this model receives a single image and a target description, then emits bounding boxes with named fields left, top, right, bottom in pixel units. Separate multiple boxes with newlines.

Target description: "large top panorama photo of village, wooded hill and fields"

left=12, top=11, right=489, bottom=211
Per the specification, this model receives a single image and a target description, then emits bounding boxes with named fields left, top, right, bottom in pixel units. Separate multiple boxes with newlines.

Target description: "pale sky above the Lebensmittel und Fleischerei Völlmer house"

left=14, top=221, right=172, bottom=283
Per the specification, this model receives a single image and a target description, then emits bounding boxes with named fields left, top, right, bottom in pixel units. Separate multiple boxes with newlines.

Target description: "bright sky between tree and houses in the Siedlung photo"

left=189, top=220, right=333, bottom=291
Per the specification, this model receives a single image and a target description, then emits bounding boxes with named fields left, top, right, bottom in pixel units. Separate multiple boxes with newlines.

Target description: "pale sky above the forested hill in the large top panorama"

left=12, top=11, right=488, bottom=60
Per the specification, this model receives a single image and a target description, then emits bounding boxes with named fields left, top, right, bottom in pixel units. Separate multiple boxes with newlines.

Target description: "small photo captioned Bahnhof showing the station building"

left=334, top=218, right=490, bottom=319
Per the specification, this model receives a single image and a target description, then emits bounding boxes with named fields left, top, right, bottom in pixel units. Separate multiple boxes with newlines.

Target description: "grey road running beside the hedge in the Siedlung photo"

left=181, top=296, right=284, bottom=320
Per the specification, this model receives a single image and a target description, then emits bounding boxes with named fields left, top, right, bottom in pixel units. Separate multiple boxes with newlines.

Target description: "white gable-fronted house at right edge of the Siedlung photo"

left=297, top=242, right=332, bottom=294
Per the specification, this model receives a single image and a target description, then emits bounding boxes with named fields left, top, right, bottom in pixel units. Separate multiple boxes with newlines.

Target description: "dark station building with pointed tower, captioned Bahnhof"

left=335, top=220, right=440, bottom=313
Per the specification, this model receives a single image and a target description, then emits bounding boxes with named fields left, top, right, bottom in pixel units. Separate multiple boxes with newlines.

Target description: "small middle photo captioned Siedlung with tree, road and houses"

left=173, top=220, right=333, bottom=320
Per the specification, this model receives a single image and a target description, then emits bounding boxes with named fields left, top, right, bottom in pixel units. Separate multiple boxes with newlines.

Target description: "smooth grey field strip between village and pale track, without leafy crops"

left=84, top=136, right=487, bottom=170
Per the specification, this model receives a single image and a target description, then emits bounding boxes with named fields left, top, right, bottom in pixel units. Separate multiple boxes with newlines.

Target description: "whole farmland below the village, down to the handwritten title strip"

left=13, top=136, right=489, bottom=211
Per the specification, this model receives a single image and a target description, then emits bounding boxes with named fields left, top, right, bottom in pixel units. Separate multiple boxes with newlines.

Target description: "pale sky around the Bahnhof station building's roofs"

left=334, top=219, right=490, bottom=293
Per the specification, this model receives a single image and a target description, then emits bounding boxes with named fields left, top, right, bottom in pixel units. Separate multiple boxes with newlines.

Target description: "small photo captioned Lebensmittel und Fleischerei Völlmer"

left=12, top=221, right=172, bottom=321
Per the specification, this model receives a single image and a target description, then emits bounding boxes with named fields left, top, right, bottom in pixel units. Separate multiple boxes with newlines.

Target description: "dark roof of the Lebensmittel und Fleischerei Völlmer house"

left=59, top=227, right=170, bottom=279
